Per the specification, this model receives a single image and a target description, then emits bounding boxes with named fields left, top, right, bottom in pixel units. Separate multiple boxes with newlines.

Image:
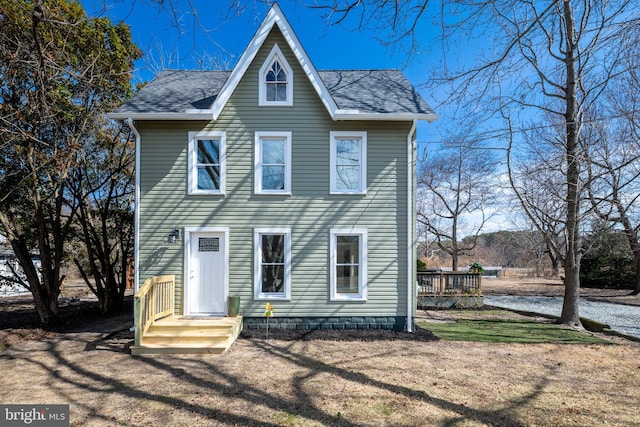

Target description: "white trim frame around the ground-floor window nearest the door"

left=253, top=228, right=291, bottom=301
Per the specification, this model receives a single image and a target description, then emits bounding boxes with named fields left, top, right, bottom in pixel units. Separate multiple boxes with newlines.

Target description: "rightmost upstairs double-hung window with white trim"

left=329, top=131, right=367, bottom=194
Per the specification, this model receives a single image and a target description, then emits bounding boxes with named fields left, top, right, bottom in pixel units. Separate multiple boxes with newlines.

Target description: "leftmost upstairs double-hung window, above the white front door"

left=187, top=131, right=226, bottom=194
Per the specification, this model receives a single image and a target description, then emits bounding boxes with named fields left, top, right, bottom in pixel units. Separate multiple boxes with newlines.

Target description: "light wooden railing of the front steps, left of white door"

left=134, top=276, right=176, bottom=346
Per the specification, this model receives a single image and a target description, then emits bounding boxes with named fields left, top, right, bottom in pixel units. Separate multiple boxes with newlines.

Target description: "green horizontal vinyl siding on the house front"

left=137, top=30, right=412, bottom=316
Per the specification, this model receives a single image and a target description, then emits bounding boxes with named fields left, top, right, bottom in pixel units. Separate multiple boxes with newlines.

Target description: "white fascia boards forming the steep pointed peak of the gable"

left=209, top=3, right=338, bottom=120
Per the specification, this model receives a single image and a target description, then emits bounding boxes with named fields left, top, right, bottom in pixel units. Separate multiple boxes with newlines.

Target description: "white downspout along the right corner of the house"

left=407, top=120, right=417, bottom=332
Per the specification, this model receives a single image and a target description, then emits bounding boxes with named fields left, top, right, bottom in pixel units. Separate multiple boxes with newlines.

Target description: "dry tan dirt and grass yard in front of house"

left=0, top=280, right=640, bottom=426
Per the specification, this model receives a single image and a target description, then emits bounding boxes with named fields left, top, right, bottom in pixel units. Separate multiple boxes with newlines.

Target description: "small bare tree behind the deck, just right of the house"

left=417, top=136, right=497, bottom=271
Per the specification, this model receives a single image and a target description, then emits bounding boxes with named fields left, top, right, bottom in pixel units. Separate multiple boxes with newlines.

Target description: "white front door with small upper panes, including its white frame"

left=185, top=232, right=227, bottom=316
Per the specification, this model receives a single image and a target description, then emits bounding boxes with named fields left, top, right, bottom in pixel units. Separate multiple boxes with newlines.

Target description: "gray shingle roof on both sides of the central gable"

left=115, top=70, right=434, bottom=118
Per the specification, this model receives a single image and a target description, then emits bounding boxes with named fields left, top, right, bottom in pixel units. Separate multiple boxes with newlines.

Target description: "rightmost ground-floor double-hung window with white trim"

left=330, top=229, right=367, bottom=301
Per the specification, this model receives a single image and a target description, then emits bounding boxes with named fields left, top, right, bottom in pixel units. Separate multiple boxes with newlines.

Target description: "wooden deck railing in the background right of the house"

left=418, top=271, right=482, bottom=296
